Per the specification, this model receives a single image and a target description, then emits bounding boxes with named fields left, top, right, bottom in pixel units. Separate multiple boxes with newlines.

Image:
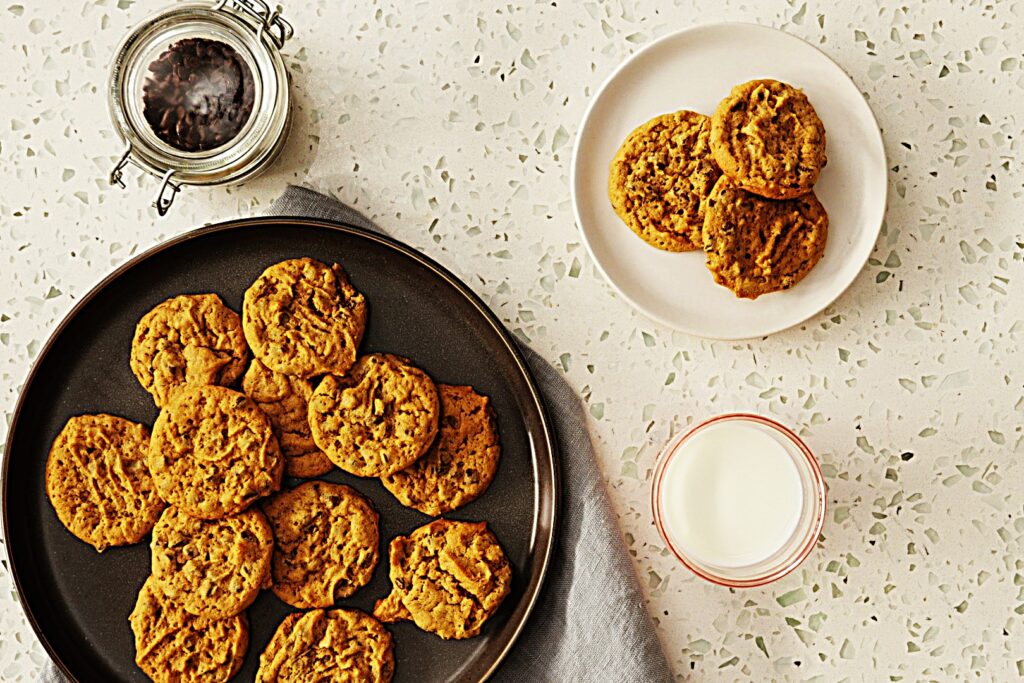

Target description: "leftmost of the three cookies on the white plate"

left=608, top=110, right=721, bottom=252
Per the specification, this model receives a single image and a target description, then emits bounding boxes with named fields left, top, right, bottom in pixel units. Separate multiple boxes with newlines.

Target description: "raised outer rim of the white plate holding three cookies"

left=569, top=22, right=889, bottom=341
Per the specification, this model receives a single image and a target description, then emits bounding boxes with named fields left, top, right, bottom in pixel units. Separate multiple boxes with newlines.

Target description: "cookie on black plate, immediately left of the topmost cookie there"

left=131, top=294, right=249, bottom=408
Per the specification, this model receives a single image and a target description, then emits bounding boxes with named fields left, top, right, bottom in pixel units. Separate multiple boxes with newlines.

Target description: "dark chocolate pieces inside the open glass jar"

left=142, top=38, right=254, bottom=152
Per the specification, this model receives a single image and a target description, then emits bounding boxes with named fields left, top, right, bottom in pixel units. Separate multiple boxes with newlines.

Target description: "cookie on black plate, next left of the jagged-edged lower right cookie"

left=263, top=481, right=380, bottom=608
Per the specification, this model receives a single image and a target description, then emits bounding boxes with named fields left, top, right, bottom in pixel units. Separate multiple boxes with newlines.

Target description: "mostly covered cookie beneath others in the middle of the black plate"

left=242, top=358, right=334, bottom=478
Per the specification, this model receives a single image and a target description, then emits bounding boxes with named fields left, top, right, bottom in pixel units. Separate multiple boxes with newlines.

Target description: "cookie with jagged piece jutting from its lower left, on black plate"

left=374, top=519, right=512, bottom=640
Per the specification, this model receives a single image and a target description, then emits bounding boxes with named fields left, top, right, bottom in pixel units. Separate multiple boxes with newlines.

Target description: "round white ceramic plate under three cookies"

left=571, top=24, right=887, bottom=339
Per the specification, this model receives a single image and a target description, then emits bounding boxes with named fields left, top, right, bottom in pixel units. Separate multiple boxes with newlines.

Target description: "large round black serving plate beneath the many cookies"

left=3, top=218, right=559, bottom=682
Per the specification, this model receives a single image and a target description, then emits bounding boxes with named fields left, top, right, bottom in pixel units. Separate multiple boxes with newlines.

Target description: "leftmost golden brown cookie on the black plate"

left=46, top=415, right=164, bottom=552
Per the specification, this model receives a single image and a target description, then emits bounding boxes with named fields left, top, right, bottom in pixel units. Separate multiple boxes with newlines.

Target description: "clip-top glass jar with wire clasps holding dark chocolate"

left=109, top=0, right=293, bottom=216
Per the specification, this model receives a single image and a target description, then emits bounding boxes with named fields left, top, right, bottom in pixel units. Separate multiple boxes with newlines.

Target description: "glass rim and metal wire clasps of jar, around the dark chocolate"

left=108, top=0, right=293, bottom=215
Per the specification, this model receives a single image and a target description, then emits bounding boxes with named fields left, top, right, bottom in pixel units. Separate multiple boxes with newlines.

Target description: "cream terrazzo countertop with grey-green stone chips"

left=0, top=0, right=1024, bottom=681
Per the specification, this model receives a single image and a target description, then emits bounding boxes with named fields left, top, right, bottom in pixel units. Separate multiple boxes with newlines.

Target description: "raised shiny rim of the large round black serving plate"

left=0, top=216, right=561, bottom=683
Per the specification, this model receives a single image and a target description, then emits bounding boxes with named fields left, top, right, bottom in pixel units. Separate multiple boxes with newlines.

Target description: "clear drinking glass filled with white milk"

left=652, top=413, right=825, bottom=588
